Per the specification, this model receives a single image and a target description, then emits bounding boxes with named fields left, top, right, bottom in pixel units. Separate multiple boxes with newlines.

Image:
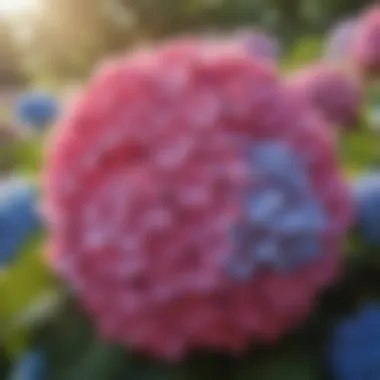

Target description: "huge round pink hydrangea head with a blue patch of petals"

left=44, top=39, right=351, bottom=360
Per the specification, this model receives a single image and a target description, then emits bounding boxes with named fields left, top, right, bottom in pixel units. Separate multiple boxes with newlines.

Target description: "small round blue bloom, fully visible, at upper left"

left=16, top=92, right=59, bottom=128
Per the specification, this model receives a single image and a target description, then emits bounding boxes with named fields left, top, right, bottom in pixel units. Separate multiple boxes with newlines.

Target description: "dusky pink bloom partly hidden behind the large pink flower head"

left=289, top=64, right=363, bottom=127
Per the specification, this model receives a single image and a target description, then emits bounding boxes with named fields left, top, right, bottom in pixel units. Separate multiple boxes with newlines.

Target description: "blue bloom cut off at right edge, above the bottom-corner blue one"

left=353, top=172, right=380, bottom=246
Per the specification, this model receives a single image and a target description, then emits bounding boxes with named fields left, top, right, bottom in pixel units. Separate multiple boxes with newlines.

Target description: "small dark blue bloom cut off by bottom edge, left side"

left=9, top=350, right=47, bottom=380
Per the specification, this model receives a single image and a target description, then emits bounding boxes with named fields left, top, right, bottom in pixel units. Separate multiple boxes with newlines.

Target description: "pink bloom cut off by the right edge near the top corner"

left=353, top=6, right=380, bottom=77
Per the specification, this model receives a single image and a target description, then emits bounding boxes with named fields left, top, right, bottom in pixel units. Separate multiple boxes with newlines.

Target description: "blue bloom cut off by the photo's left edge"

left=0, top=179, right=40, bottom=265
